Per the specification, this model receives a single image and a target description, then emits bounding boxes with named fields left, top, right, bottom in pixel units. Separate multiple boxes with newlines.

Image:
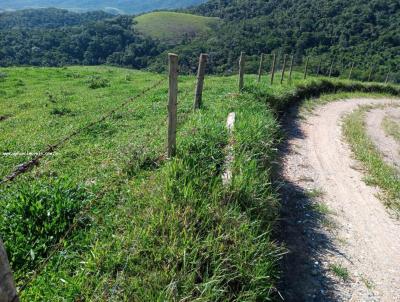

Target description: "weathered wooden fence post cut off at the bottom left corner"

left=0, top=238, right=19, bottom=302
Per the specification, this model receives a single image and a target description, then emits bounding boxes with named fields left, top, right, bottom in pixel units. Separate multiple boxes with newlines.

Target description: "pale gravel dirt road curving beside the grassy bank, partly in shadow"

left=280, top=99, right=400, bottom=302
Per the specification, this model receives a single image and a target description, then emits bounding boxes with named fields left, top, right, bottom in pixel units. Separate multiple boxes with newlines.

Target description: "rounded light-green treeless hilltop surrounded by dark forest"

left=135, top=12, right=218, bottom=44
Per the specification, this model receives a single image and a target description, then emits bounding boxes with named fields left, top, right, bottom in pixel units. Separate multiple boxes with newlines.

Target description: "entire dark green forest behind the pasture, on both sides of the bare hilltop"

left=0, top=0, right=400, bottom=82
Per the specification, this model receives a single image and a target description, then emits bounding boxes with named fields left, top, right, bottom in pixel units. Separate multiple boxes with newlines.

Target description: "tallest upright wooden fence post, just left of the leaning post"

left=167, top=53, right=178, bottom=158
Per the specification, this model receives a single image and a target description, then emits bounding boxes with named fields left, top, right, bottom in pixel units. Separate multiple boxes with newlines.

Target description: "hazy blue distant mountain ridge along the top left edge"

left=0, top=0, right=206, bottom=14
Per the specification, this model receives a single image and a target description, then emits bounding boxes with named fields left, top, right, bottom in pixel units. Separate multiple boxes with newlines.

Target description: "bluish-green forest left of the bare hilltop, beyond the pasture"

left=0, top=9, right=163, bottom=68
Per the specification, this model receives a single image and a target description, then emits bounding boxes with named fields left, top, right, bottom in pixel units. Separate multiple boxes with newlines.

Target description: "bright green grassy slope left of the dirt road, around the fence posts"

left=0, top=67, right=400, bottom=301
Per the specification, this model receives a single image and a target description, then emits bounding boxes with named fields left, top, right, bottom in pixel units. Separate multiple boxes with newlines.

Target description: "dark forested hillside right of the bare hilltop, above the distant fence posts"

left=163, top=0, right=400, bottom=79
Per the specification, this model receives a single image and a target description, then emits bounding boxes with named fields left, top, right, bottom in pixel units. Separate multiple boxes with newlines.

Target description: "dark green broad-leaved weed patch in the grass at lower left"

left=0, top=179, right=89, bottom=270
